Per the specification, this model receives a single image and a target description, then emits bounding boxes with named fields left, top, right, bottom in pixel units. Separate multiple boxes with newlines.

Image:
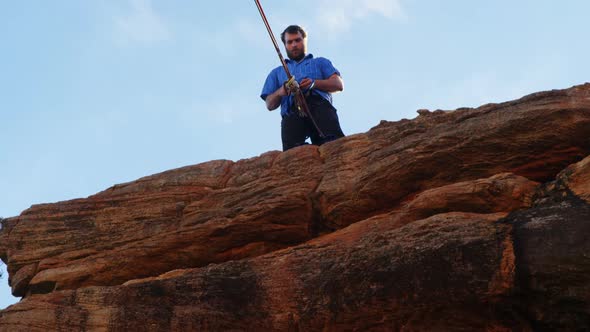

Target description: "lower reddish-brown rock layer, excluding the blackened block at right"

left=0, top=213, right=514, bottom=331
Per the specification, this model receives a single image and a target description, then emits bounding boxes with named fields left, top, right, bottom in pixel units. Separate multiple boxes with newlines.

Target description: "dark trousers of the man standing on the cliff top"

left=281, top=94, right=344, bottom=151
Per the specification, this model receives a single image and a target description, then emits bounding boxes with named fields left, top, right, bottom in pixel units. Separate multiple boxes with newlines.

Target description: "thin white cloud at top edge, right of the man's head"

left=317, top=0, right=407, bottom=33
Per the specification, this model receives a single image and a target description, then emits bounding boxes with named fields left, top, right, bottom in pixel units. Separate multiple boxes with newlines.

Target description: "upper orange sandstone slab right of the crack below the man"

left=317, top=84, right=590, bottom=229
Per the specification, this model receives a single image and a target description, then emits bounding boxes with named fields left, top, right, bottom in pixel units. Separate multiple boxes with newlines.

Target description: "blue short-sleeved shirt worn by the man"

left=260, top=54, right=340, bottom=116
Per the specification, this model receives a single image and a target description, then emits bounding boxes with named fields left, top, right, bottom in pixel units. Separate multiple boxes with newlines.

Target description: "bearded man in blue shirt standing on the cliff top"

left=260, top=25, right=344, bottom=151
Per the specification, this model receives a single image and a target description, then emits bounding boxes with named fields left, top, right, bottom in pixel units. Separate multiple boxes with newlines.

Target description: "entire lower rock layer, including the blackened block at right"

left=0, top=189, right=590, bottom=331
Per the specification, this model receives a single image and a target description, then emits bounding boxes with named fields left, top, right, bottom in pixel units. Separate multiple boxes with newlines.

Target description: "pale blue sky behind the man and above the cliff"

left=0, top=0, right=590, bottom=308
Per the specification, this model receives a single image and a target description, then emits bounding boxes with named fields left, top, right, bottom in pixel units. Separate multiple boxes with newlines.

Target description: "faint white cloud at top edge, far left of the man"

left=115, top=0, right=171, bottom=45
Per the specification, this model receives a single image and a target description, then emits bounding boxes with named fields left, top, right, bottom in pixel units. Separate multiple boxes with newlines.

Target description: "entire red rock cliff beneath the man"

left=0, top=84, right=590, bottom=331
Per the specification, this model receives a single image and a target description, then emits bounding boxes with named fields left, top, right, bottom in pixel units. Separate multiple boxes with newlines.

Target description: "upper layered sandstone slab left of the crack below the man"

left=8, top=148, right=320, bottom=296
